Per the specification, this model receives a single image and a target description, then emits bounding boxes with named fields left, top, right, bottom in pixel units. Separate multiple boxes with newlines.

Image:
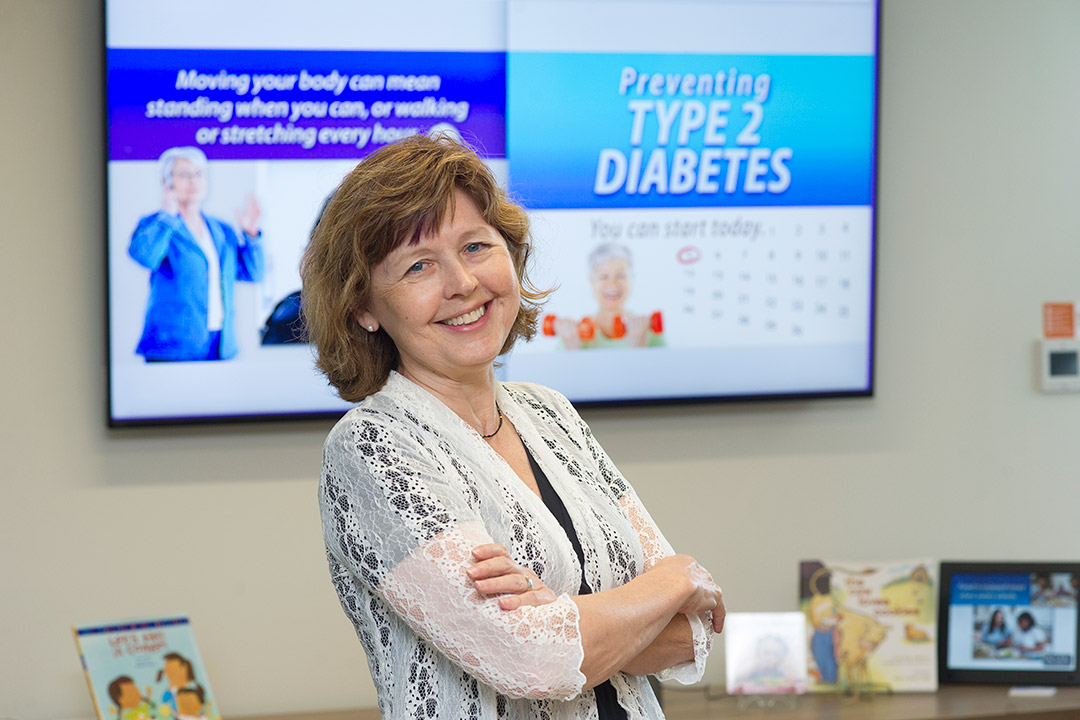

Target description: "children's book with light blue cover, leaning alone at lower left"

left=71, top=617, right=220, bottom=720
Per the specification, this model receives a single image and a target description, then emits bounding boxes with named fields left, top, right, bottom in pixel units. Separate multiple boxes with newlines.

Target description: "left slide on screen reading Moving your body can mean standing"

left=106, top=0, right=507, bottom=423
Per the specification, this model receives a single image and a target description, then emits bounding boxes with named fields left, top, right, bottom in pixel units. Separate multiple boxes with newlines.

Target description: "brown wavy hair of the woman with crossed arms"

left=300, top=135, right=550, bottom=403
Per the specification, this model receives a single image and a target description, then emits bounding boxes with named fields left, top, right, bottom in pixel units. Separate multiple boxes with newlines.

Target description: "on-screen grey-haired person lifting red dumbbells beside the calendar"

left=542, top=243, right=665, bottom=350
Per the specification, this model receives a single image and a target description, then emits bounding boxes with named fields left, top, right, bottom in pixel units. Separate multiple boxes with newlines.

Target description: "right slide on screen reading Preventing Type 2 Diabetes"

left=503, top=0, right=877, bottom=402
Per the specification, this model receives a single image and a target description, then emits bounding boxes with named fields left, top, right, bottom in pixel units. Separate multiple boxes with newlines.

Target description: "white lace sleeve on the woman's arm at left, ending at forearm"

left=321, top=412, right=585, bottom=699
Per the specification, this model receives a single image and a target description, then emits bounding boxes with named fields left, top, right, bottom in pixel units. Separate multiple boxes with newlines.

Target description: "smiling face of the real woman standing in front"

left=357, top=190, right=521, bottom=381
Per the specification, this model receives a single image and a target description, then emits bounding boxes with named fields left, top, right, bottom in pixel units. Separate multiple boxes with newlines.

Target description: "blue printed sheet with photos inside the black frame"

left=947, top=573, right=1078, bottom=673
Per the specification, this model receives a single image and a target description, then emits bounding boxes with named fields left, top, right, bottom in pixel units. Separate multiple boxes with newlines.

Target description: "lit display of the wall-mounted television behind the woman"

left=104, top=0, right=879, bottom=426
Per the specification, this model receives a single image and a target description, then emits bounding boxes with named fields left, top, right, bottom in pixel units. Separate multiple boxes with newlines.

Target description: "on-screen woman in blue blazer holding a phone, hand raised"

left=127, top=147, right=265, bottom=362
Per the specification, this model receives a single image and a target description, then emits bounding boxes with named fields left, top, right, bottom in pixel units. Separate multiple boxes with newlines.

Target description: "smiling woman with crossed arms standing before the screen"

left=300, top=136, right=724, bottom=720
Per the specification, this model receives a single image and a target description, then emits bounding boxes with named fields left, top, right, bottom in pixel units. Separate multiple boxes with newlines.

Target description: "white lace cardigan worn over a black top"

left=320, top=372, right=712, bottom=720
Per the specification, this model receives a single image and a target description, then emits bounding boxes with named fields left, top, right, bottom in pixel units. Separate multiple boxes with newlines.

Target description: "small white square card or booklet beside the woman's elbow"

left=724, top=612, right=807, bottom=695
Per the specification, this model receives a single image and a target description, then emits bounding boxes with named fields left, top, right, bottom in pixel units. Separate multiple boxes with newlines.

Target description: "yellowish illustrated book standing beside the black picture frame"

left=799, top=560, right=937, bottom=693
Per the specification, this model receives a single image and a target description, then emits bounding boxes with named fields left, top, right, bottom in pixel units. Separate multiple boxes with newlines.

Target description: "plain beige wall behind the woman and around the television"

left=0, top=0, right=1080, bottom=720
